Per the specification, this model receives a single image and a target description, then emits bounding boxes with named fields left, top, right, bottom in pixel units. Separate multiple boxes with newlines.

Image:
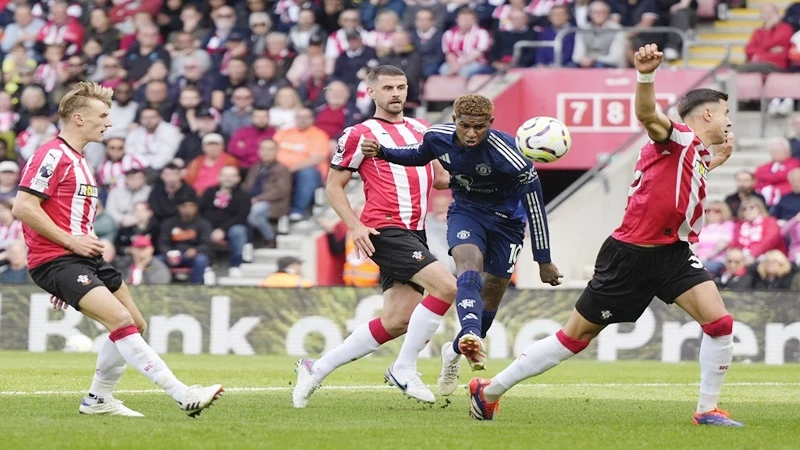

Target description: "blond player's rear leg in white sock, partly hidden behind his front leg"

left=79, top=283, right=147, bottom=417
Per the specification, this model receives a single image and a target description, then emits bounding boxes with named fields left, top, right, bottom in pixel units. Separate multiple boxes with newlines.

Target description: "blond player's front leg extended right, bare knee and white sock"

left=78, top=286, right=222, bottom=417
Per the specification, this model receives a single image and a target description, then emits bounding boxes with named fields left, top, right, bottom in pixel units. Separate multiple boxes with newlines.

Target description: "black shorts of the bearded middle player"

left=370, top=227, right=436, bottom=294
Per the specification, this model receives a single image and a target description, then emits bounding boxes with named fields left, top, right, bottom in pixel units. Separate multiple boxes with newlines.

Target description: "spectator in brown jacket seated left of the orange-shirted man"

left=242, top=139, right=292, bottom=247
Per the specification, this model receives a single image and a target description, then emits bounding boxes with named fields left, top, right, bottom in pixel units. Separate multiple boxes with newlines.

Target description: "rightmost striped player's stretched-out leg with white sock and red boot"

left=469, top=309, right=605, bottom=420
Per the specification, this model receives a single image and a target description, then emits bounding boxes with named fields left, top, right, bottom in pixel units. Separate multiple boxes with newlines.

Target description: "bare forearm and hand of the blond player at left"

left=11, top=190, right=103, bottom=257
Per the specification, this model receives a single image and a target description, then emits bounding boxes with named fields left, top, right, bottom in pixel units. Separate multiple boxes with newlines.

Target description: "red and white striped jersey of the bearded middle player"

left=331, top=117, right=433, bottom=230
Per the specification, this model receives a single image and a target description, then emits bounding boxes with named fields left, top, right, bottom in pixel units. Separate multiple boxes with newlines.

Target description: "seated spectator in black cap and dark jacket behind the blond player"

left=158, top=193, right=211, bottom=284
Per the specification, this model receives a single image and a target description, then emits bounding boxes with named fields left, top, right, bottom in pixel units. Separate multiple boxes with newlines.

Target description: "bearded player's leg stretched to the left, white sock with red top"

left=292, top=283, right=422, bottom=408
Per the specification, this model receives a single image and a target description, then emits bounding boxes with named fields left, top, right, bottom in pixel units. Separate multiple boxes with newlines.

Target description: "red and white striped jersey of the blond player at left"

left=19, top=137, right=97, bottom=269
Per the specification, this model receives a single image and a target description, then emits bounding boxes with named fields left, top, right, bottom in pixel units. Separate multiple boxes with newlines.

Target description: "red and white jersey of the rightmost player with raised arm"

left=611, top=122, right=711, bottom=244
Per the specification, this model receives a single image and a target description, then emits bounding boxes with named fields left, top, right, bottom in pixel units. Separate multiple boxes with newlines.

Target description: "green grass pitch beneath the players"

left=0, top=352, right=800, bottom=450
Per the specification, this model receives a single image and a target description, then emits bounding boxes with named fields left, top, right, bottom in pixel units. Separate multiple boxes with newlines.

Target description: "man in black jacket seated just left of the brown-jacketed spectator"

left=200, top=166, right=251, bottom=278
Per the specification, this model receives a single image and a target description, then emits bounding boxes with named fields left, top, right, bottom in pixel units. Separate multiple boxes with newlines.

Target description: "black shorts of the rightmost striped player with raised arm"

left=575, top=237, right=711, bottom=325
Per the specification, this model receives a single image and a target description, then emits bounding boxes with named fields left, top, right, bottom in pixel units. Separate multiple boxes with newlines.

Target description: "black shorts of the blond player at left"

left=30, top=255, right=122, bottom=311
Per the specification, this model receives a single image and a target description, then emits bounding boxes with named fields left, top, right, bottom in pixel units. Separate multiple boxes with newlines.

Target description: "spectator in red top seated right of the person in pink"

left=731, top=197, right=786, bottom=264
